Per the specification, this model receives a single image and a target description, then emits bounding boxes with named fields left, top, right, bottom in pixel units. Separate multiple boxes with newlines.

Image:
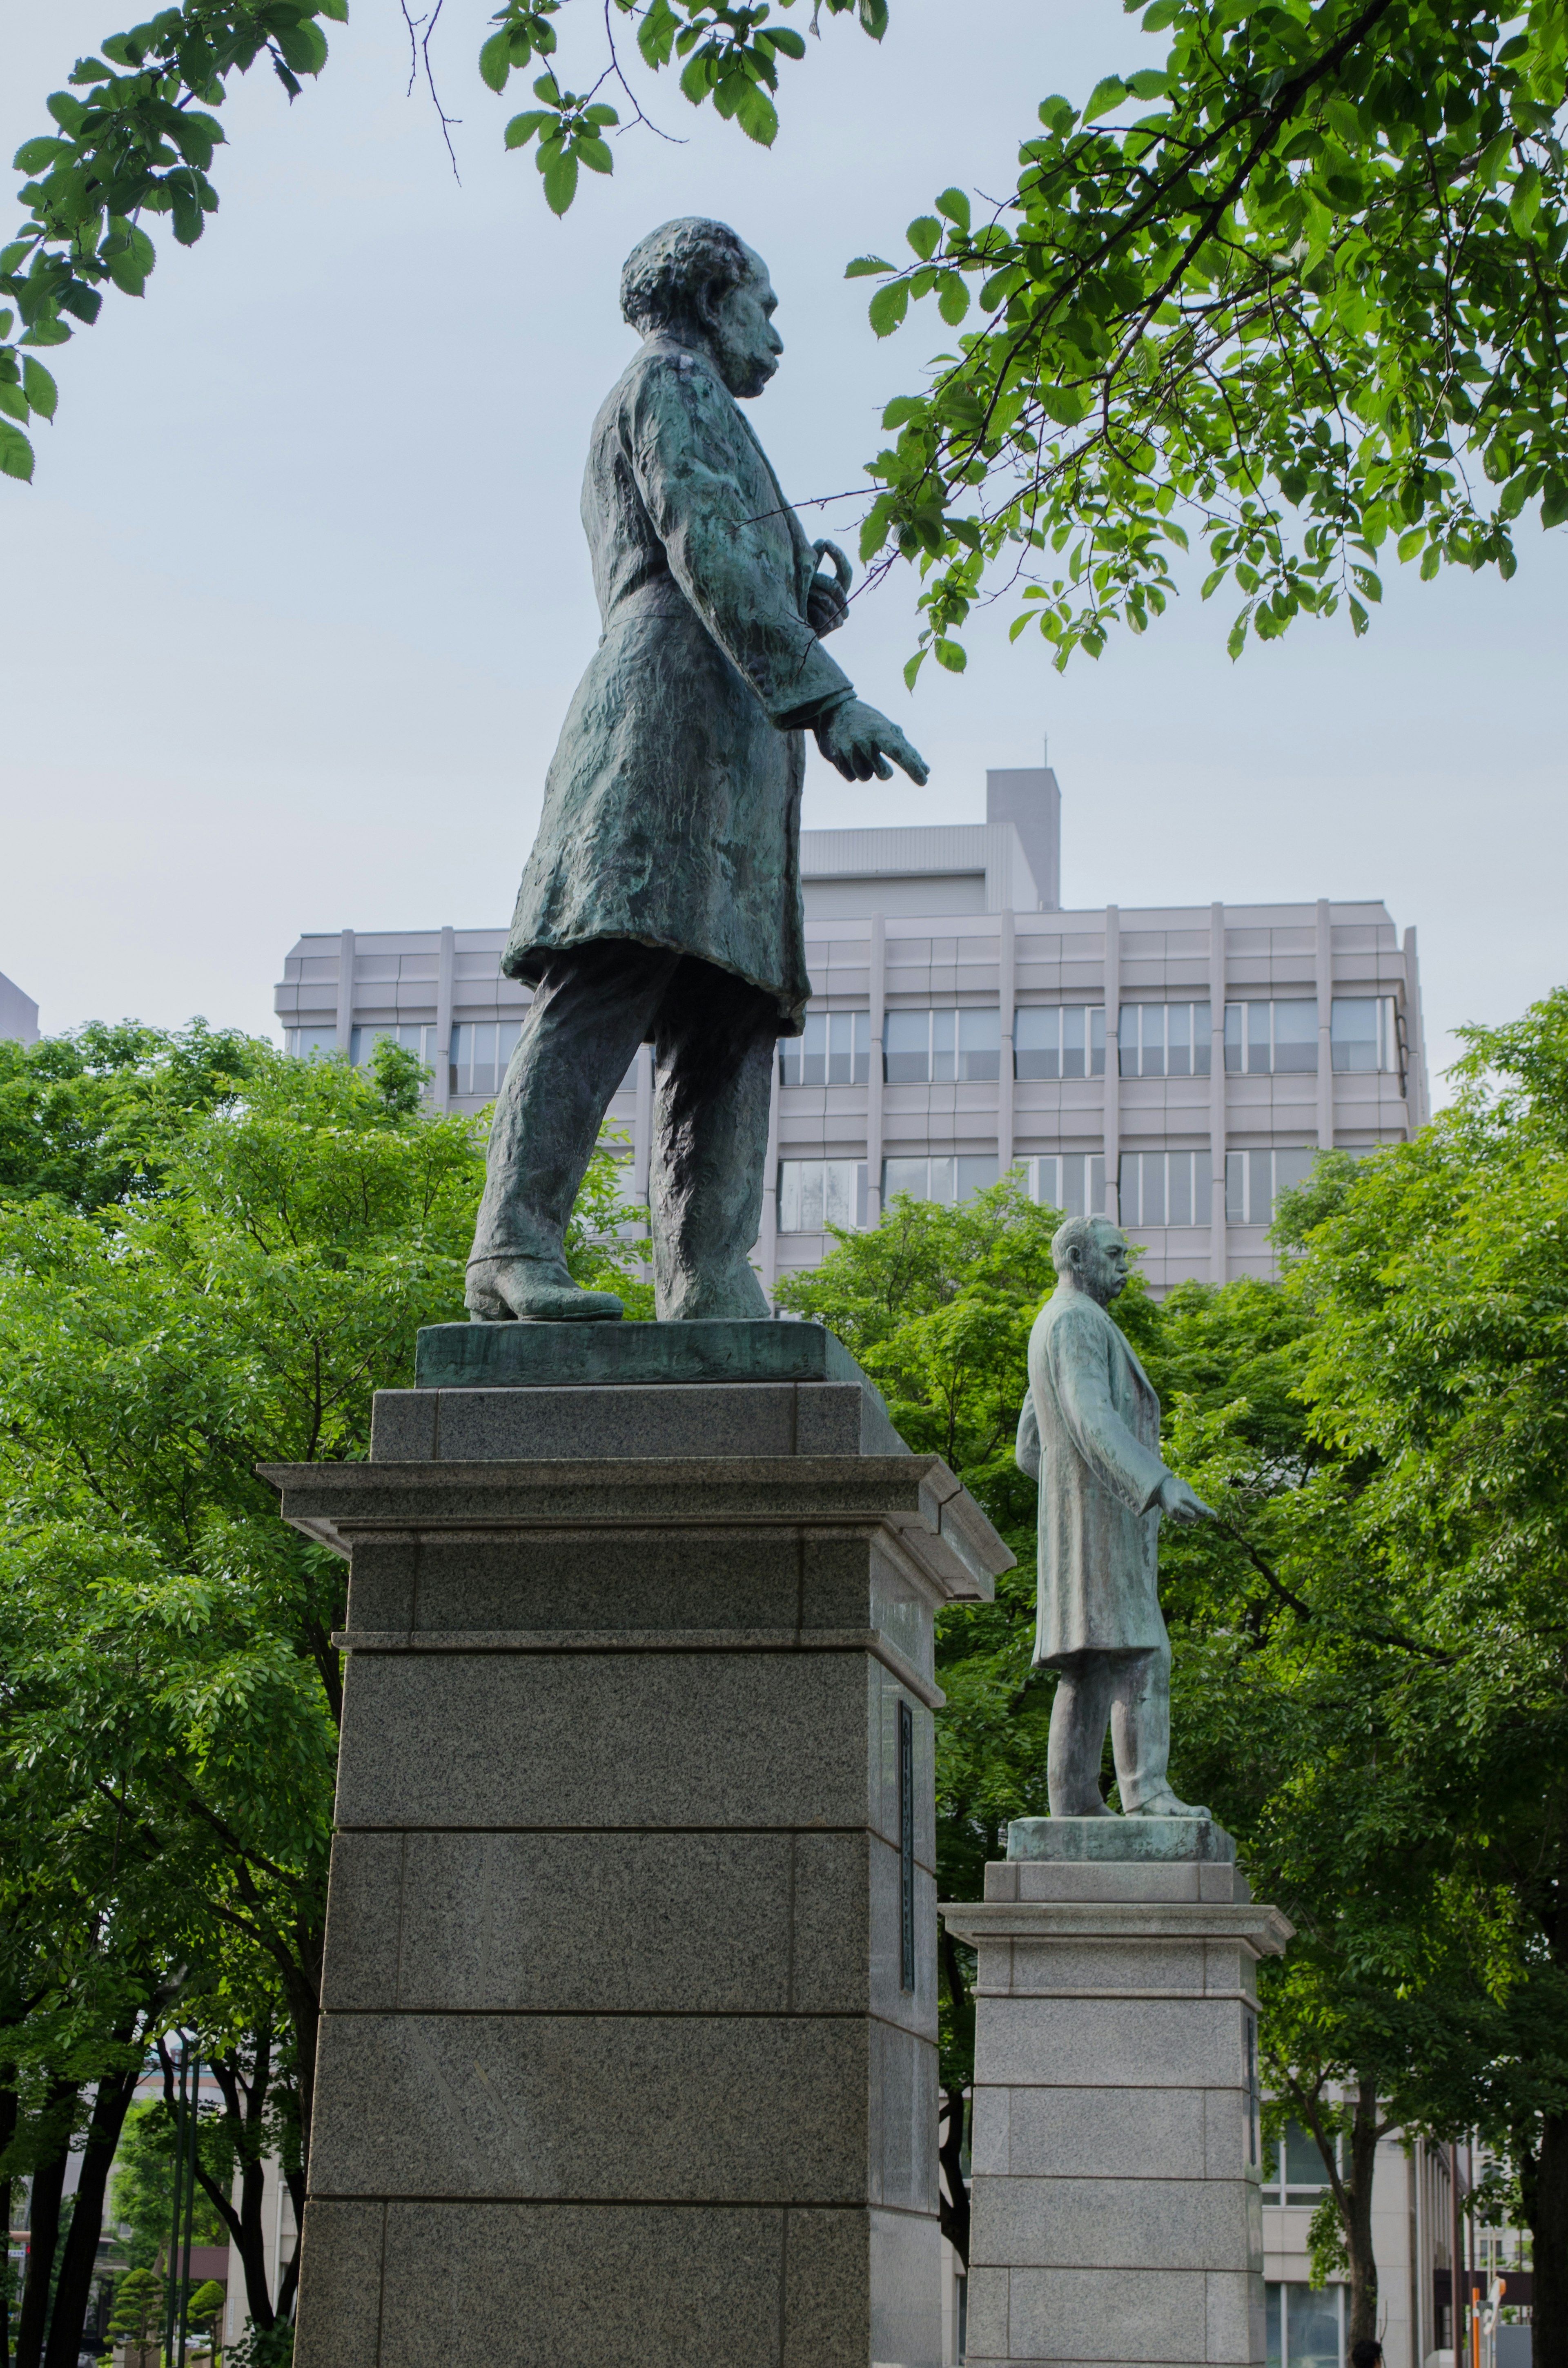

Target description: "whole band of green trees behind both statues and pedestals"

left=0, top=990, right=1568, bottom=2368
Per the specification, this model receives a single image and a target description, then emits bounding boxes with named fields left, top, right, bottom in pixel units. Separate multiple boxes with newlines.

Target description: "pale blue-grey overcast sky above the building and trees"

left=0, top=0, right=1568, bottom=1089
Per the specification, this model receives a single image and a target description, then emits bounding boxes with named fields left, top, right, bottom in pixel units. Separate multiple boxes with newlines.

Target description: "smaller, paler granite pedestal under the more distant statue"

left=943, top=1816, right=1291, bottom=2368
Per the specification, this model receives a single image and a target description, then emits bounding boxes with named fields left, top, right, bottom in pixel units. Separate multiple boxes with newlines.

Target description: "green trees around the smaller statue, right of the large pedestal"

left=782, top=992, right=1568, bottom=2368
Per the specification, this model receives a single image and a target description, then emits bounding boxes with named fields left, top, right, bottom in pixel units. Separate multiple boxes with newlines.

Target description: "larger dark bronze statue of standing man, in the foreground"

left=467, top=218, right=926, bottom=1321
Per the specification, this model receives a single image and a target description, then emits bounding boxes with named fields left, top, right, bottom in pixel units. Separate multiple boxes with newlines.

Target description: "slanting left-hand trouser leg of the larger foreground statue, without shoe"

left=469, top=938, right=680, bottom=1279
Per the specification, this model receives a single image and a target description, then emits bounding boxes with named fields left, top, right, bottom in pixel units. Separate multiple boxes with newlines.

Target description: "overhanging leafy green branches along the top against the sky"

left=0, top=0, right=1568, bottom=680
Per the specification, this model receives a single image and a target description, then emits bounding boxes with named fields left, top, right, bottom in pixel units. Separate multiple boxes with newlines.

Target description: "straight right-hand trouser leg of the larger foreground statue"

left=649, top=957, right=779, bottom=1321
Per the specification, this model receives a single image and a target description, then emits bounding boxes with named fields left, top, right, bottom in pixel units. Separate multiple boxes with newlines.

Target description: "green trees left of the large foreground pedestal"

left=0, top=1023, right=647, bottom=2368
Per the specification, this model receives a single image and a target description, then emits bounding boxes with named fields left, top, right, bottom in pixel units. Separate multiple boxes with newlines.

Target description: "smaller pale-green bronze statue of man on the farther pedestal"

left=1016, top=1217, right=1213, bottom=1816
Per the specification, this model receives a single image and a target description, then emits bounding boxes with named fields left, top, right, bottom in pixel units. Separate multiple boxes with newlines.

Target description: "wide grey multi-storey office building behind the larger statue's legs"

left=277, top=767, right=1428, bottom=1291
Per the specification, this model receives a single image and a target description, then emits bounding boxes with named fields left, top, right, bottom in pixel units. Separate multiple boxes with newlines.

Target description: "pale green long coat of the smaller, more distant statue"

left=1016, top=1281, right=1165, bottom=1662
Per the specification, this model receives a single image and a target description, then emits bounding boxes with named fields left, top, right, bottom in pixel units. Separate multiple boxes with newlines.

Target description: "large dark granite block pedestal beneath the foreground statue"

left=270, top=1324, right=1009, bottom=2368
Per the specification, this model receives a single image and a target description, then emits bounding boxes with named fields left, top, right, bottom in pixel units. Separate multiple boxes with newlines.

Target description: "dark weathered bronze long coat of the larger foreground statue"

left=502, top=336, right=850, bottom=1035
